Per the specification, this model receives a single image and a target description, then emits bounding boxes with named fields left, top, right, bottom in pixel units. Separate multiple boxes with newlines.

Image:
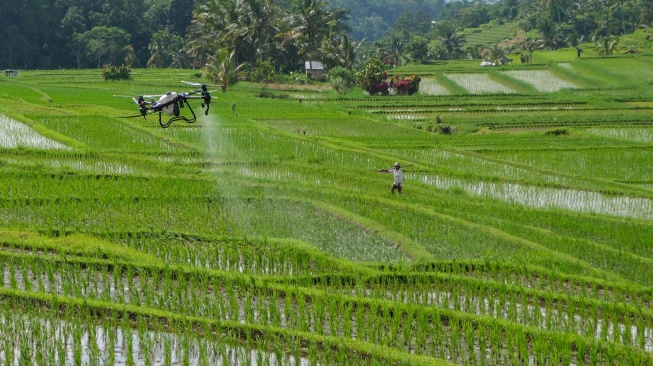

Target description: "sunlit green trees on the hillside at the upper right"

left=358, top=0, right=653, bottom=65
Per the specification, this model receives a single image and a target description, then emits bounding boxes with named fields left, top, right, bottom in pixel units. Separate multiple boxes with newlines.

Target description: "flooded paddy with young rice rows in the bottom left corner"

left=0, top=314, right=316, bottom=366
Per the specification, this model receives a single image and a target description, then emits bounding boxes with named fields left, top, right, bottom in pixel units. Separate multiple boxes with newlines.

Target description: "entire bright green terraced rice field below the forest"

left=0, top=49, right=653, bottom=365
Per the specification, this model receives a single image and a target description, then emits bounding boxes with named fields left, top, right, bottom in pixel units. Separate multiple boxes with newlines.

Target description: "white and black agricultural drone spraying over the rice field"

left=119, top=80, right=218, bottom=128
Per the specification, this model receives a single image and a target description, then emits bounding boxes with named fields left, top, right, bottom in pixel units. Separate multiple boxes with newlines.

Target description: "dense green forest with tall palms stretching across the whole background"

left=0, top=0, right=653, bottom=72
